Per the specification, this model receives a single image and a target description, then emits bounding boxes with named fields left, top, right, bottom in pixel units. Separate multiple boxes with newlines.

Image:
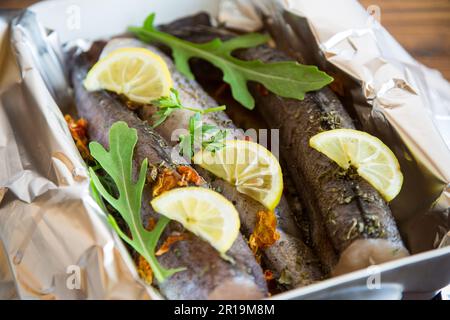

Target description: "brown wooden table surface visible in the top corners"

left=0, top=0, right=450, bottom=80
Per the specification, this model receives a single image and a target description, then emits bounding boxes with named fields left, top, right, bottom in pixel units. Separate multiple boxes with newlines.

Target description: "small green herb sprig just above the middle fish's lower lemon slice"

left=180, top=113, right=227, bottom=158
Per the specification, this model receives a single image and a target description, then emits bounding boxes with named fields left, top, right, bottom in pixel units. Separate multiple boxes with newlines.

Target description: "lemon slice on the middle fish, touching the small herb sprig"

left=193, top=140, right=283, bottom=210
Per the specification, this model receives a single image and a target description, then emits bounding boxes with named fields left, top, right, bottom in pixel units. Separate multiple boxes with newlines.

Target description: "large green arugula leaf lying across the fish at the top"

left=129, top=14, right=333, bottom=109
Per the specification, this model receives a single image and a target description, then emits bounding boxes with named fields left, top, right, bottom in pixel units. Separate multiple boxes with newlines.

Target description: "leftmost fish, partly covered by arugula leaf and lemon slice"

left=71, top=50, right=268, bottom=299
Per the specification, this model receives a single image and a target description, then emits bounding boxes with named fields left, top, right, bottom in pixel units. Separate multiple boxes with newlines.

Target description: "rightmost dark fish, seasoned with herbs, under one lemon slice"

left=161, top=14, right=408, bottom=274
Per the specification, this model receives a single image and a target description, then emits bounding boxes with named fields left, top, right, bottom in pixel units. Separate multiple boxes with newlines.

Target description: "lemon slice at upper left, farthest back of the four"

left=84, top=48, right=172, bottom=103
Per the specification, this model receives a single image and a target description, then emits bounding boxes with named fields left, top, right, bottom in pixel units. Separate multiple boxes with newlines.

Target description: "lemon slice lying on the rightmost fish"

left=309, top=129, right=403, bottom=201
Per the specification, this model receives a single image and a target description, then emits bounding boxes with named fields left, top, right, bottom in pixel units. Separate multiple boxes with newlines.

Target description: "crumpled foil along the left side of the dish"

left=0, top=12, right=158, bottom=299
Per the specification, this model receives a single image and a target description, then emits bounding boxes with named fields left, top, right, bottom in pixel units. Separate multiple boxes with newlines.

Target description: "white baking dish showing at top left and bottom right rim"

left=2, top=0, right=450, bottom=299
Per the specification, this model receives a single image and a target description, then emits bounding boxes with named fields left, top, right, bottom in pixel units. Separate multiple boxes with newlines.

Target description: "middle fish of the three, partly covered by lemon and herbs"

left=99, top=39, right=324, bottom=288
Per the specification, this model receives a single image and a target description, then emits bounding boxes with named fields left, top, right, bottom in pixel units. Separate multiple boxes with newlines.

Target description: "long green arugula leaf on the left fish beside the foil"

left=89, top=121, right=184, bottom=282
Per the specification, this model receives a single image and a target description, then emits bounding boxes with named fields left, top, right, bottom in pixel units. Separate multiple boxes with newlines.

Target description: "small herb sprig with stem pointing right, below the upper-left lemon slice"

left=152, top=88, right=225, bottom=128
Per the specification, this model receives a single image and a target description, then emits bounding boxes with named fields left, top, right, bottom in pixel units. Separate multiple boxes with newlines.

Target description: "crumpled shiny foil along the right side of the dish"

left=219, top=0, right=450, bottom=253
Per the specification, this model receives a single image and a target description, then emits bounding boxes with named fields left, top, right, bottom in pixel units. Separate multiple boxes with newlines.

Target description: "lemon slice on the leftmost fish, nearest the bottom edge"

left=151, top=187, right=240, bottom=253
